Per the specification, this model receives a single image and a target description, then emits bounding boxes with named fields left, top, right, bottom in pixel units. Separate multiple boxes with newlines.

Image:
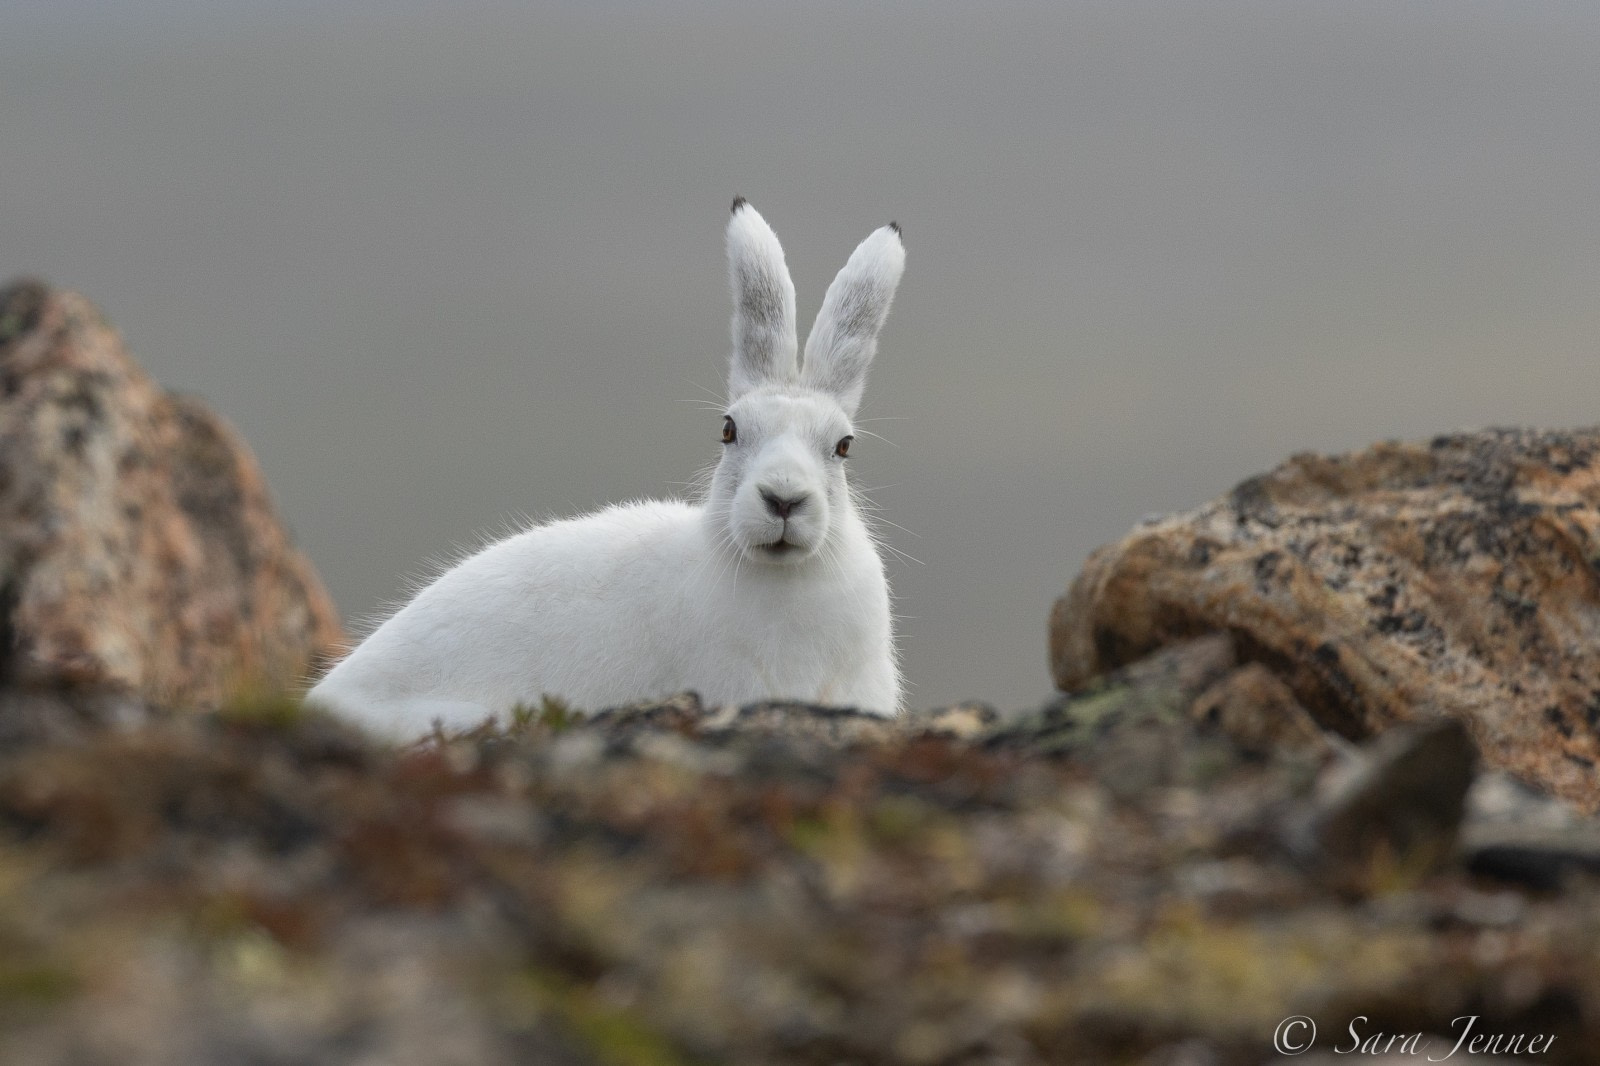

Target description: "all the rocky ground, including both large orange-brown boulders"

left=0, top=282, right=1600, bottom=1066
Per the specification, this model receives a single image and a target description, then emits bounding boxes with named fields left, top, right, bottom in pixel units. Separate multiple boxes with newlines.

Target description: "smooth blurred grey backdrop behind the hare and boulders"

left=0, top=0, right=1600, bottom=706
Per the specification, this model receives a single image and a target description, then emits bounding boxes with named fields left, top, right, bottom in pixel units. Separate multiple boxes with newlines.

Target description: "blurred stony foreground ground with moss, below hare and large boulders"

left=0, top=656, right=1600, bottom=1066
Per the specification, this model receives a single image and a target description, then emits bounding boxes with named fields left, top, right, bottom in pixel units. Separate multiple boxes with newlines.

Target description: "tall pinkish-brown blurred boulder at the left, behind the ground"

left=0, top=282, right=341, bottom=707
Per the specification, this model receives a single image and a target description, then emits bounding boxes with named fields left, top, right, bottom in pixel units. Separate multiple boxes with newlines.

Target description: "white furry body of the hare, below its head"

left=305, top=501, right=899, bottom=736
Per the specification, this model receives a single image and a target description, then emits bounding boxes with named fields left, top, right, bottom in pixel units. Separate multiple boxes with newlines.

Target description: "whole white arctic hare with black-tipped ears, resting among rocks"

left=307, top=197, right=906, bottom=738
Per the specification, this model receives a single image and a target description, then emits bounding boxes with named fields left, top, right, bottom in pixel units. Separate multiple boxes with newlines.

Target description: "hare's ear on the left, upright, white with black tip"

left=728, top=197, right=798, bottom=400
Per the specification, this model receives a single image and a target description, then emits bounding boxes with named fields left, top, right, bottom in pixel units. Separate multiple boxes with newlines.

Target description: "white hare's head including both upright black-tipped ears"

left=707, top=197, right=906, bottom=565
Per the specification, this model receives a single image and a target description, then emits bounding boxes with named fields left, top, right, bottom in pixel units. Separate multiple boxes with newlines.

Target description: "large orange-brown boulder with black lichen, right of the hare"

left=1050, top=429, right=1600, bottom=810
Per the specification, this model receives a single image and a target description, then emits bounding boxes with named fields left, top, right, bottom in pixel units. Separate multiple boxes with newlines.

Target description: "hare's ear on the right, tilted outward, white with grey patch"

left=800, top=222, right=906, bottom=416
